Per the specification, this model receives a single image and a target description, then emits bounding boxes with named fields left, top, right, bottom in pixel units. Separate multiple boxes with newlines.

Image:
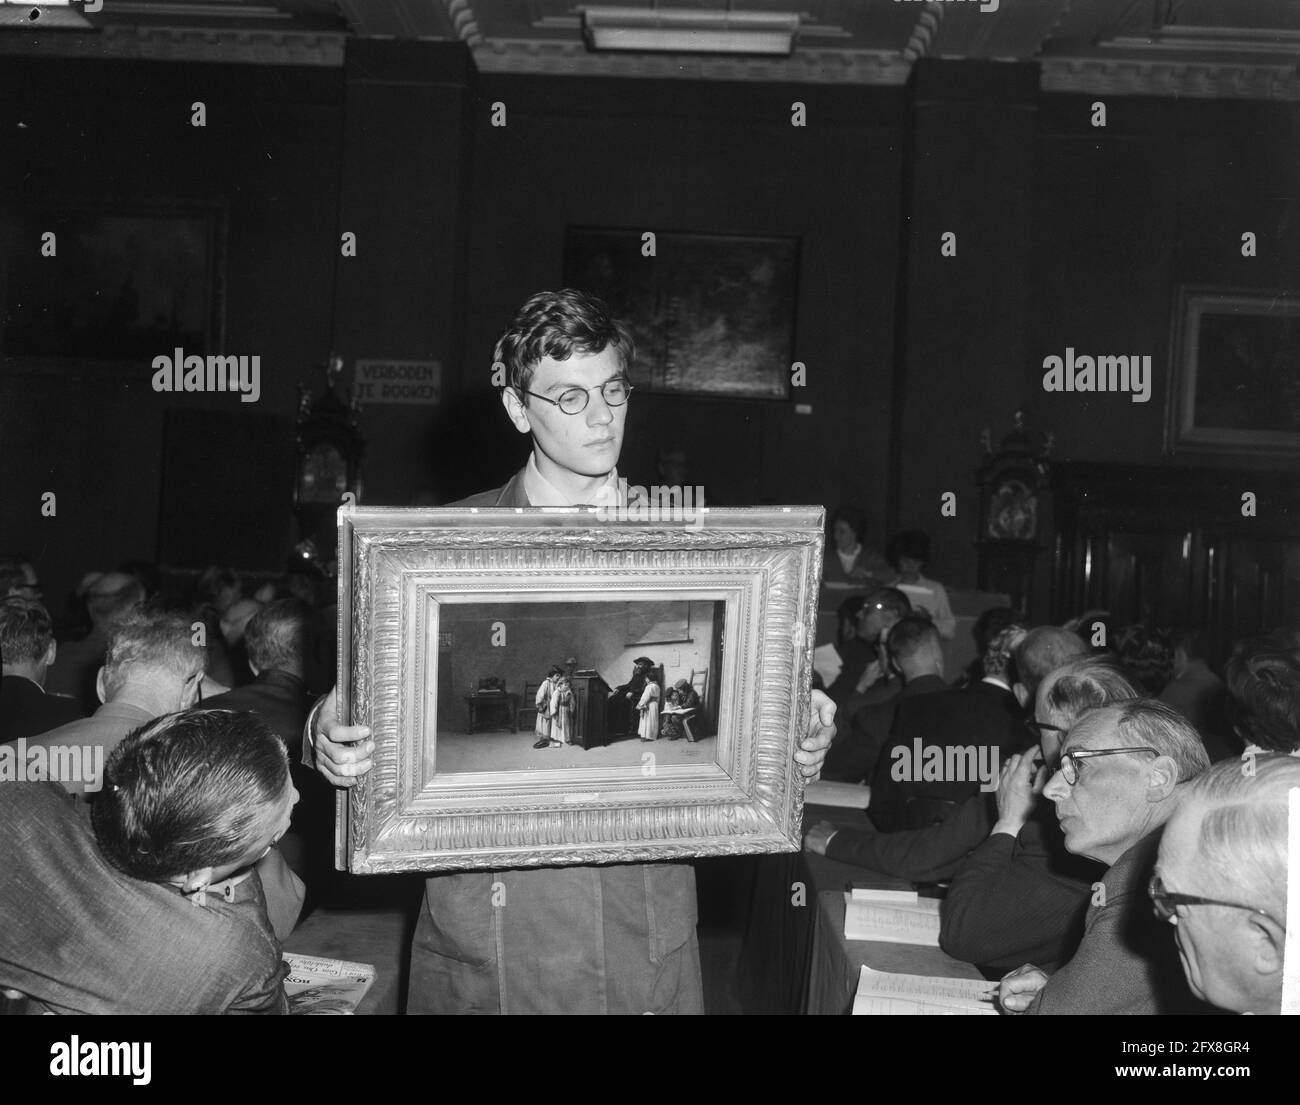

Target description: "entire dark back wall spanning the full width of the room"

left=0, top=42, right=1300, bottom=624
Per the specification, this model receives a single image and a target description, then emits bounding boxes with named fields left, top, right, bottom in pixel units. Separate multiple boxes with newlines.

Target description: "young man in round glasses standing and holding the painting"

left=306, top=289, right=835, bottom=1013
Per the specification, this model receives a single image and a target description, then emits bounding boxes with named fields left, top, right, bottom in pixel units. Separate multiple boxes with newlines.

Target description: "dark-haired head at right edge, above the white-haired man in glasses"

left=1223, top=629, right=1300, bottom=753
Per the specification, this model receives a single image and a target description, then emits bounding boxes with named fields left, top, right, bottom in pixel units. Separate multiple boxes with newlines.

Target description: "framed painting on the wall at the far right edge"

left=1165, top=287, right=1300, bottom=455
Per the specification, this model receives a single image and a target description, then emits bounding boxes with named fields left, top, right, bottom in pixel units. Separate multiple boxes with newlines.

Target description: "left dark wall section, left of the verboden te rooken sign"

left=0, top=59, right=342, bottom=612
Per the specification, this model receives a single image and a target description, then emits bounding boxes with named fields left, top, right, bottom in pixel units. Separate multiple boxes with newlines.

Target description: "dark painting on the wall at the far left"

left=0, top=207, right=225, bottom=361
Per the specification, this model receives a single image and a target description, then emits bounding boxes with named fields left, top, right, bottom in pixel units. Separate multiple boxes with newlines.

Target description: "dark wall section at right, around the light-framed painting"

left=1026, top=96, right=1300, bottom=467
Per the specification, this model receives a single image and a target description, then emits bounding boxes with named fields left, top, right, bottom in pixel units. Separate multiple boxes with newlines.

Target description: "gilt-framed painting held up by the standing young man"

left=337, top=507, right=823, bottom=874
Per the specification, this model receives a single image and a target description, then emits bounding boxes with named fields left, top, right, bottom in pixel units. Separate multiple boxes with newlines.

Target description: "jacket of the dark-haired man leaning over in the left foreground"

left=0, top=783, right=289, bottom=1014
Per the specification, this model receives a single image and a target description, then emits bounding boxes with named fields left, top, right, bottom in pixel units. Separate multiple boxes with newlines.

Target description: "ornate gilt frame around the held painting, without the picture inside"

left=335, top=507, right=824, bottom=874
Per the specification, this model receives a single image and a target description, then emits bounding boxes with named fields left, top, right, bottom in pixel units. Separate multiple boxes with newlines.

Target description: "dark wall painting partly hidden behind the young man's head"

left=564, top=226, right=798, bottom=399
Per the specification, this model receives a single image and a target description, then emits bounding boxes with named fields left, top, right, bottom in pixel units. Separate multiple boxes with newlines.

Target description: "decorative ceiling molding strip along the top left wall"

left=0, top=26, right=347, bottom=68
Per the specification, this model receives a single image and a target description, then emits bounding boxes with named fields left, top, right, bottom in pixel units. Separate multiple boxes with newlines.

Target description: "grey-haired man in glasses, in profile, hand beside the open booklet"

left=998, top=698, right=1209, bottom=1015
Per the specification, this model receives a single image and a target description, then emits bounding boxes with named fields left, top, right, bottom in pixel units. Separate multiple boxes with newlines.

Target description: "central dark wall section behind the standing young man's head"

left=456, top=77, right=902, bottom=527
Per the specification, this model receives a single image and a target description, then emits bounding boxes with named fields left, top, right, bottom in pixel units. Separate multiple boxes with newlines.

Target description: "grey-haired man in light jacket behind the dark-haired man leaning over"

left=27, top=611, right=303, bottom=936
